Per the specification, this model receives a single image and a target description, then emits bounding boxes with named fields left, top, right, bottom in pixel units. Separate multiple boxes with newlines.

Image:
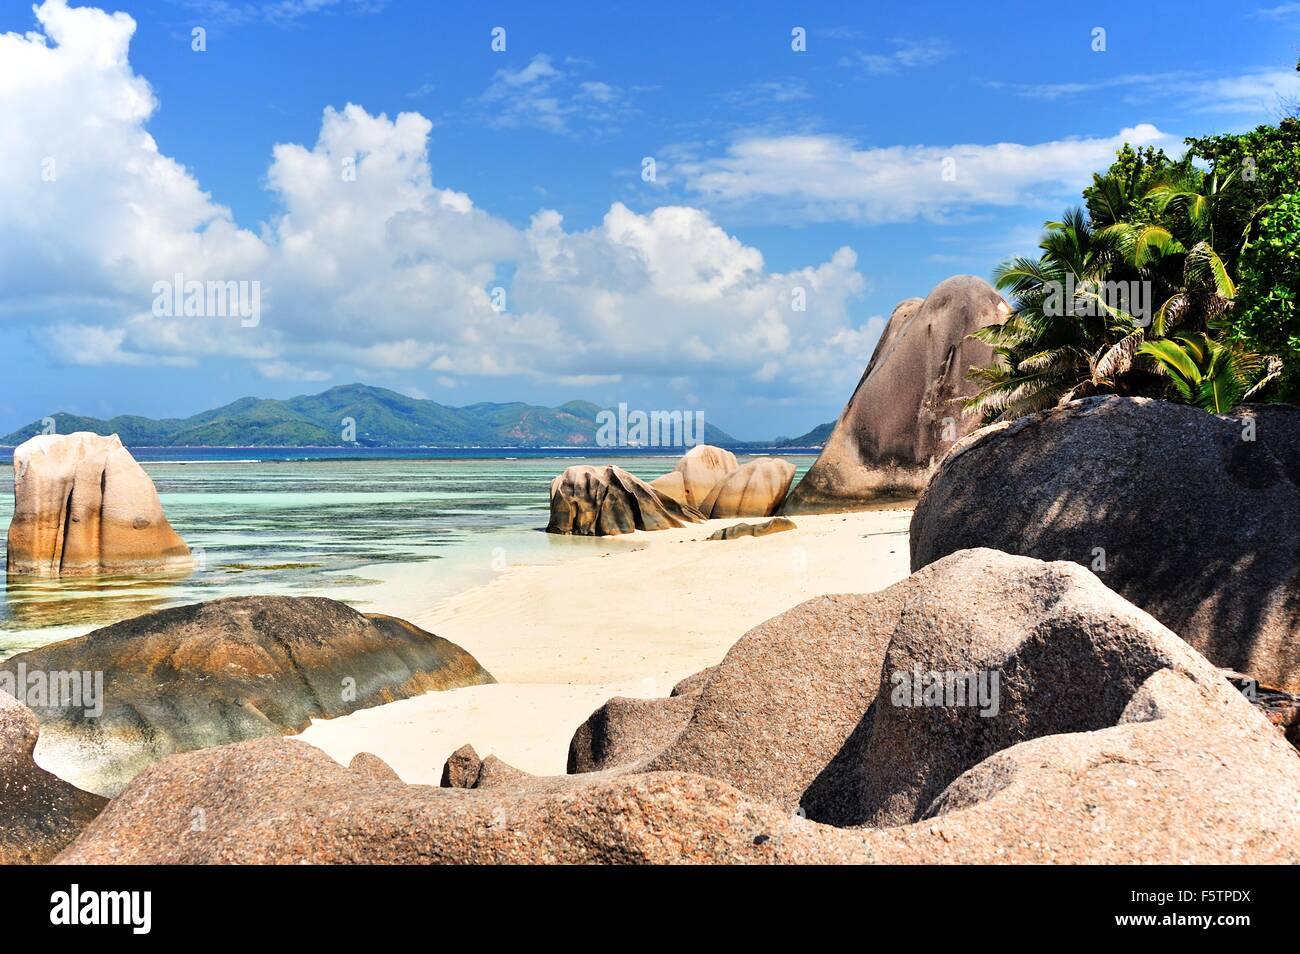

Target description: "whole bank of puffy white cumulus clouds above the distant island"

left=0, top=0, right=865, bottom=400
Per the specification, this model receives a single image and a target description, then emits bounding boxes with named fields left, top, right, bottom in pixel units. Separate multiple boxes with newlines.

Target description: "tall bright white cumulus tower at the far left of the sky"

left=0, top=0, right=265, bottom=321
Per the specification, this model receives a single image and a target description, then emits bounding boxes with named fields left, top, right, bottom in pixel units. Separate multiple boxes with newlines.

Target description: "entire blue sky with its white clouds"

left=0, top=0, right=1300, bottom=438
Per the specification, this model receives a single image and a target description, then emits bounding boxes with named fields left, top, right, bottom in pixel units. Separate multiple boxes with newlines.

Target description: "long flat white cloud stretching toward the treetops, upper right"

left=675, top=123, right=1178, bottom=224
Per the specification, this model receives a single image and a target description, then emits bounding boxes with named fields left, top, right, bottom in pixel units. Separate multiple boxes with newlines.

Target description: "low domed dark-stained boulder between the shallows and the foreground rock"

left=0, top=597, right=495, bottom=794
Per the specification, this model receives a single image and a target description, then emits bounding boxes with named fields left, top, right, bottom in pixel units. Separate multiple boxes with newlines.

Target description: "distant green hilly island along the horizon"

left=0, top=385, right=832, bottom=448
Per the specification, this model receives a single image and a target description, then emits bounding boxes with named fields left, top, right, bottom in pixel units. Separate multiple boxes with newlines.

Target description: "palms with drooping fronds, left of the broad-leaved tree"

left=966, top=147, right=1275, bottom=422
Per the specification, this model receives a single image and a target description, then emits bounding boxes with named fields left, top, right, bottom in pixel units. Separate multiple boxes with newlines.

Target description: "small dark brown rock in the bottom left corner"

left=0, top=691, right=107, bottom=864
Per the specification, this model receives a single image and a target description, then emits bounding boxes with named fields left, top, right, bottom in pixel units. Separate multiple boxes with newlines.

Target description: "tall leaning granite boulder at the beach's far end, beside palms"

left=781, top=276, right=1009, bottom=515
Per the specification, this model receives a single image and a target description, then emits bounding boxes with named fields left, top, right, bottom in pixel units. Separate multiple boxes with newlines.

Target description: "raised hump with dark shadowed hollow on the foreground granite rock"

left=842, top=550, right=1227, bottom=827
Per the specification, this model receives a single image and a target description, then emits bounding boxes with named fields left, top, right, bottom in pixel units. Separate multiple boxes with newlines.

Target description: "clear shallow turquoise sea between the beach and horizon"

left=0, top=448, right=815, bottom=658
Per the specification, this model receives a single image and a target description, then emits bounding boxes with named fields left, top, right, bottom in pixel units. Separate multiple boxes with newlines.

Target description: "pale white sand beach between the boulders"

left=296, top=506, right=911, bottom=785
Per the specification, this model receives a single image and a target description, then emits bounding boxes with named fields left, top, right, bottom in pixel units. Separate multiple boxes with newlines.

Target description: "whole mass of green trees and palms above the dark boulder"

left=966, top=120, right=1300, bottom=421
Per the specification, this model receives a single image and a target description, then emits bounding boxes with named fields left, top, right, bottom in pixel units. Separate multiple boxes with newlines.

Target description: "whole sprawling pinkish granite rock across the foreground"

left=59, top=550, right=1300, bottom=864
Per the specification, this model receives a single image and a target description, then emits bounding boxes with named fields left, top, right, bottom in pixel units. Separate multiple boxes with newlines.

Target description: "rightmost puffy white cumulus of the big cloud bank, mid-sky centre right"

left=515, top=203, right=865, bottom=374
